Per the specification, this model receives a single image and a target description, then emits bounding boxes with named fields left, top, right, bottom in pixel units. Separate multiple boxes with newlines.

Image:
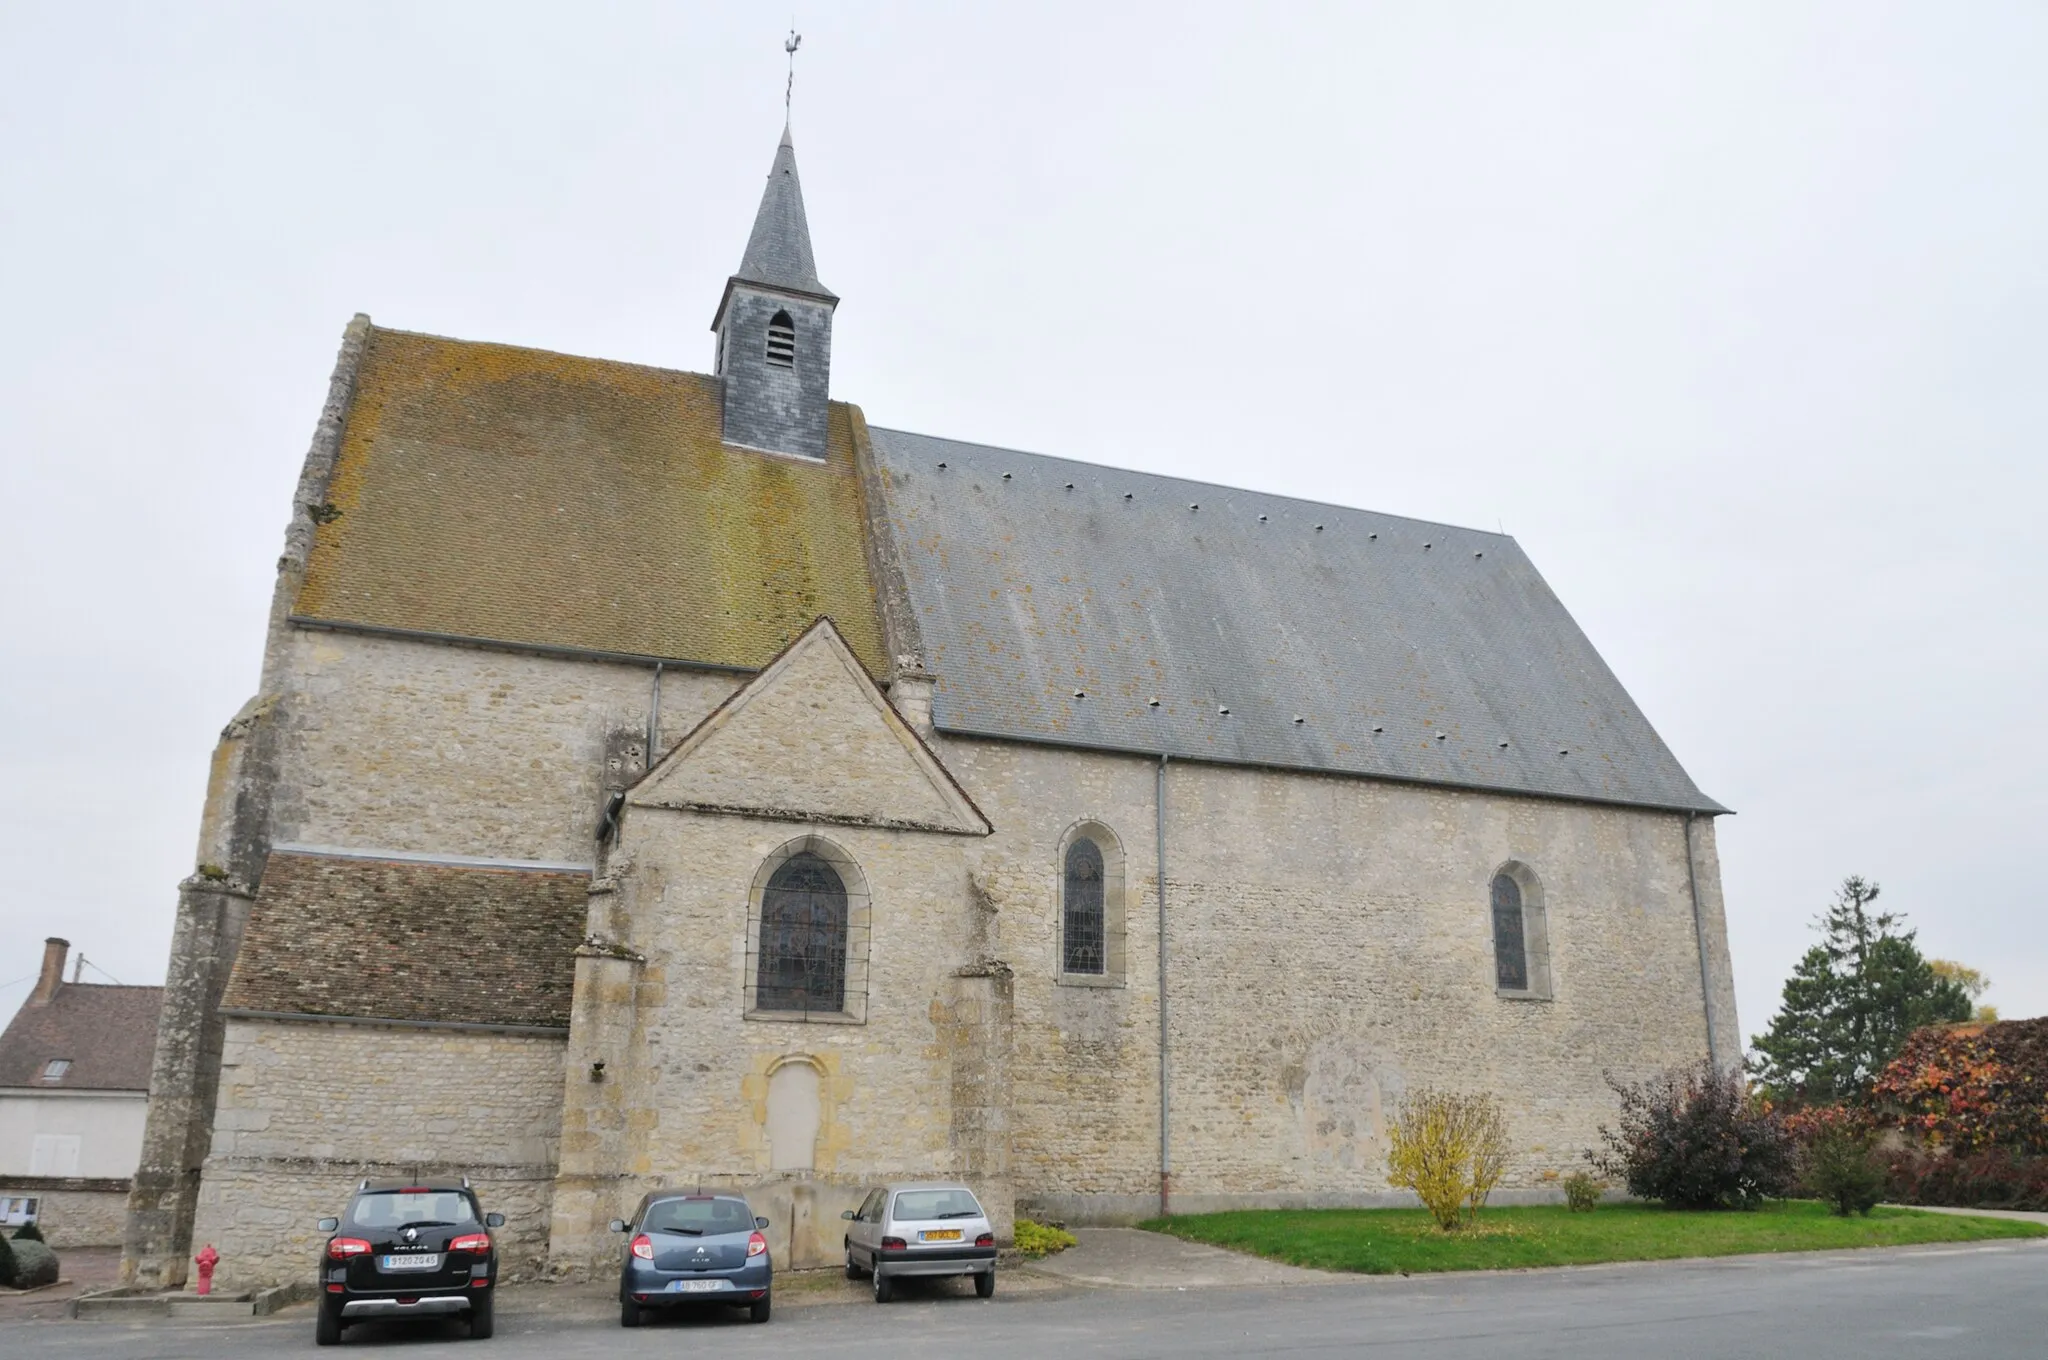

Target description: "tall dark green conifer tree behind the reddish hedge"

left=1749, top=875, right=1970, bottom=1102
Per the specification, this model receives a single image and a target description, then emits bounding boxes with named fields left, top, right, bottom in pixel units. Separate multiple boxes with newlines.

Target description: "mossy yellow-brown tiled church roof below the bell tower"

left=293, top=330, right=887, bottom=676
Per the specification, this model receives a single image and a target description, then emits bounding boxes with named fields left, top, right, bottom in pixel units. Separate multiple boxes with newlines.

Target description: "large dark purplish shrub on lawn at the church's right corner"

left=1585, top=1061, right=1798, bottom=1208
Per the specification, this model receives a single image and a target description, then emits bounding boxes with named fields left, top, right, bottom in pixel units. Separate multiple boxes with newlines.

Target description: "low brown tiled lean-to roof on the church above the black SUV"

left=223, top=852, right=590, bottom=1026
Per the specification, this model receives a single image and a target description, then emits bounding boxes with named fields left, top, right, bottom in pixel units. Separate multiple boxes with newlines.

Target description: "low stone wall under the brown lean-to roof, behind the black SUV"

left=193, top=1020, right=563, bottom=1290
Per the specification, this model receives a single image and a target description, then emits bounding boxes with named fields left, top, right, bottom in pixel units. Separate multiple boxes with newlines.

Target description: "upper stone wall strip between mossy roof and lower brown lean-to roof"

left=274, top=629, right=737, bottom=864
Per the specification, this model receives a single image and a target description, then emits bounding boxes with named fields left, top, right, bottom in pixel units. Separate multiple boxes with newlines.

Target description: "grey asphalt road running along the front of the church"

left=19, top=1243, right=2048, bottom=1360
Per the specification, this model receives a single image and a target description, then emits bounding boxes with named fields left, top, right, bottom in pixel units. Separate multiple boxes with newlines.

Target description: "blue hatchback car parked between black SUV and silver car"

left=612, top=1190, right=774, bottom=1327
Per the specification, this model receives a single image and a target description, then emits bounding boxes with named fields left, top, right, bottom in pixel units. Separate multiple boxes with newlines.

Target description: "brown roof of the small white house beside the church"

left=0, top=983, right=164, bottom=1092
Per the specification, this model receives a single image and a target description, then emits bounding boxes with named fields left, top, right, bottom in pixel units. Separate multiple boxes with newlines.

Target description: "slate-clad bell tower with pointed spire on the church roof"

left=711, top=127, right=840, bottom=461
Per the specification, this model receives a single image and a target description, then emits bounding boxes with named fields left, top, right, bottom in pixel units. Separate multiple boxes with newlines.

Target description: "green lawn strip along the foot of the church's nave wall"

left=1139, top=1200, right=2048, bottom=1274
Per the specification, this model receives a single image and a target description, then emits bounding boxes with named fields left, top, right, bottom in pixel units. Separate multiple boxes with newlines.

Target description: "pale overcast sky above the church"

left=0, top=0, right=2048, bottom=1034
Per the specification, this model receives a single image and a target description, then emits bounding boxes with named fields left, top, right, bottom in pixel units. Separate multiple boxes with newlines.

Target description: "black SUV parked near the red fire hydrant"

left=313, top=1176, right=506, bottom=1346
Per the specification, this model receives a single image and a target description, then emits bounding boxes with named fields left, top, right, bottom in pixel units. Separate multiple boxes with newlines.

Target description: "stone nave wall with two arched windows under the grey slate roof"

left=942, top=739, right=1735, bottom=1219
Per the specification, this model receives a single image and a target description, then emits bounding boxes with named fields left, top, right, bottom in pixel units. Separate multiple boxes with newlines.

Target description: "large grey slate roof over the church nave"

left=870, top=428, right=1726, bottom=813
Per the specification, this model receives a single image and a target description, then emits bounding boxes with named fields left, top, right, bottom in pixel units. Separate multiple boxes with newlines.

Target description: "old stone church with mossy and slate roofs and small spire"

left=123, top=119, right=1739, bottom=1288
